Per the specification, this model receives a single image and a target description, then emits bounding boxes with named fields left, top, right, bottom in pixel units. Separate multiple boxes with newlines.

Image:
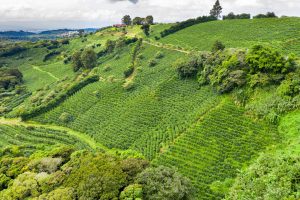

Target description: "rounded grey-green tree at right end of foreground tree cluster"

left=137, top=166, right=192, bottom=200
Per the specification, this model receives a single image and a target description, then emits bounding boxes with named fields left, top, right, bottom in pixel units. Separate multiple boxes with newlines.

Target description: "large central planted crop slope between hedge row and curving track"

left=35, top=45, right=218, bottom=159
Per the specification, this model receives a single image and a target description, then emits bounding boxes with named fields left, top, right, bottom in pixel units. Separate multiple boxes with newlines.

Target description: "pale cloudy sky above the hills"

left=0, top=0, right=300, bottom=30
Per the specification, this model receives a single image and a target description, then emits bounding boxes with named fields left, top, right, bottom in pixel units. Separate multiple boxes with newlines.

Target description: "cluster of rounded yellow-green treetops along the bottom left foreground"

left=0, top=146, right=191, bottom=200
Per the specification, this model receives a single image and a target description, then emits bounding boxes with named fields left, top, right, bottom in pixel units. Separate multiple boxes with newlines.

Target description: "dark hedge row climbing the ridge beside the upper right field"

left=160, top=16, right=217, bottom=37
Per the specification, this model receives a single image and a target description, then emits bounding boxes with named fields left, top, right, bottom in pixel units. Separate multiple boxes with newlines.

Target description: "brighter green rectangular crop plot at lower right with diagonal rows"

left=153, top=102, right=277, bottom=199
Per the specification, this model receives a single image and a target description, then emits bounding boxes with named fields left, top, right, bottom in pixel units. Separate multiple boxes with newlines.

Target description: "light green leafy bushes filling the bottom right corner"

left=226, top=151, right=300, bottom=200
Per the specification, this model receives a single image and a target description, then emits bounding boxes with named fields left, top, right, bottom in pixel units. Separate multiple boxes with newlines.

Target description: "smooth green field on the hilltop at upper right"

left=160, top=17, right=300, bottom=55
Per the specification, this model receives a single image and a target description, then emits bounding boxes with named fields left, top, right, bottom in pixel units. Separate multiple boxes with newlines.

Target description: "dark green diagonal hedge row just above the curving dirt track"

left=20, top=75, right=99, bottom=120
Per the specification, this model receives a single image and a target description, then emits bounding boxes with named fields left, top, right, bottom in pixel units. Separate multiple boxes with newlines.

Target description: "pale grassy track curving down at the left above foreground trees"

left=0, top=118, right=109, bottom=151
